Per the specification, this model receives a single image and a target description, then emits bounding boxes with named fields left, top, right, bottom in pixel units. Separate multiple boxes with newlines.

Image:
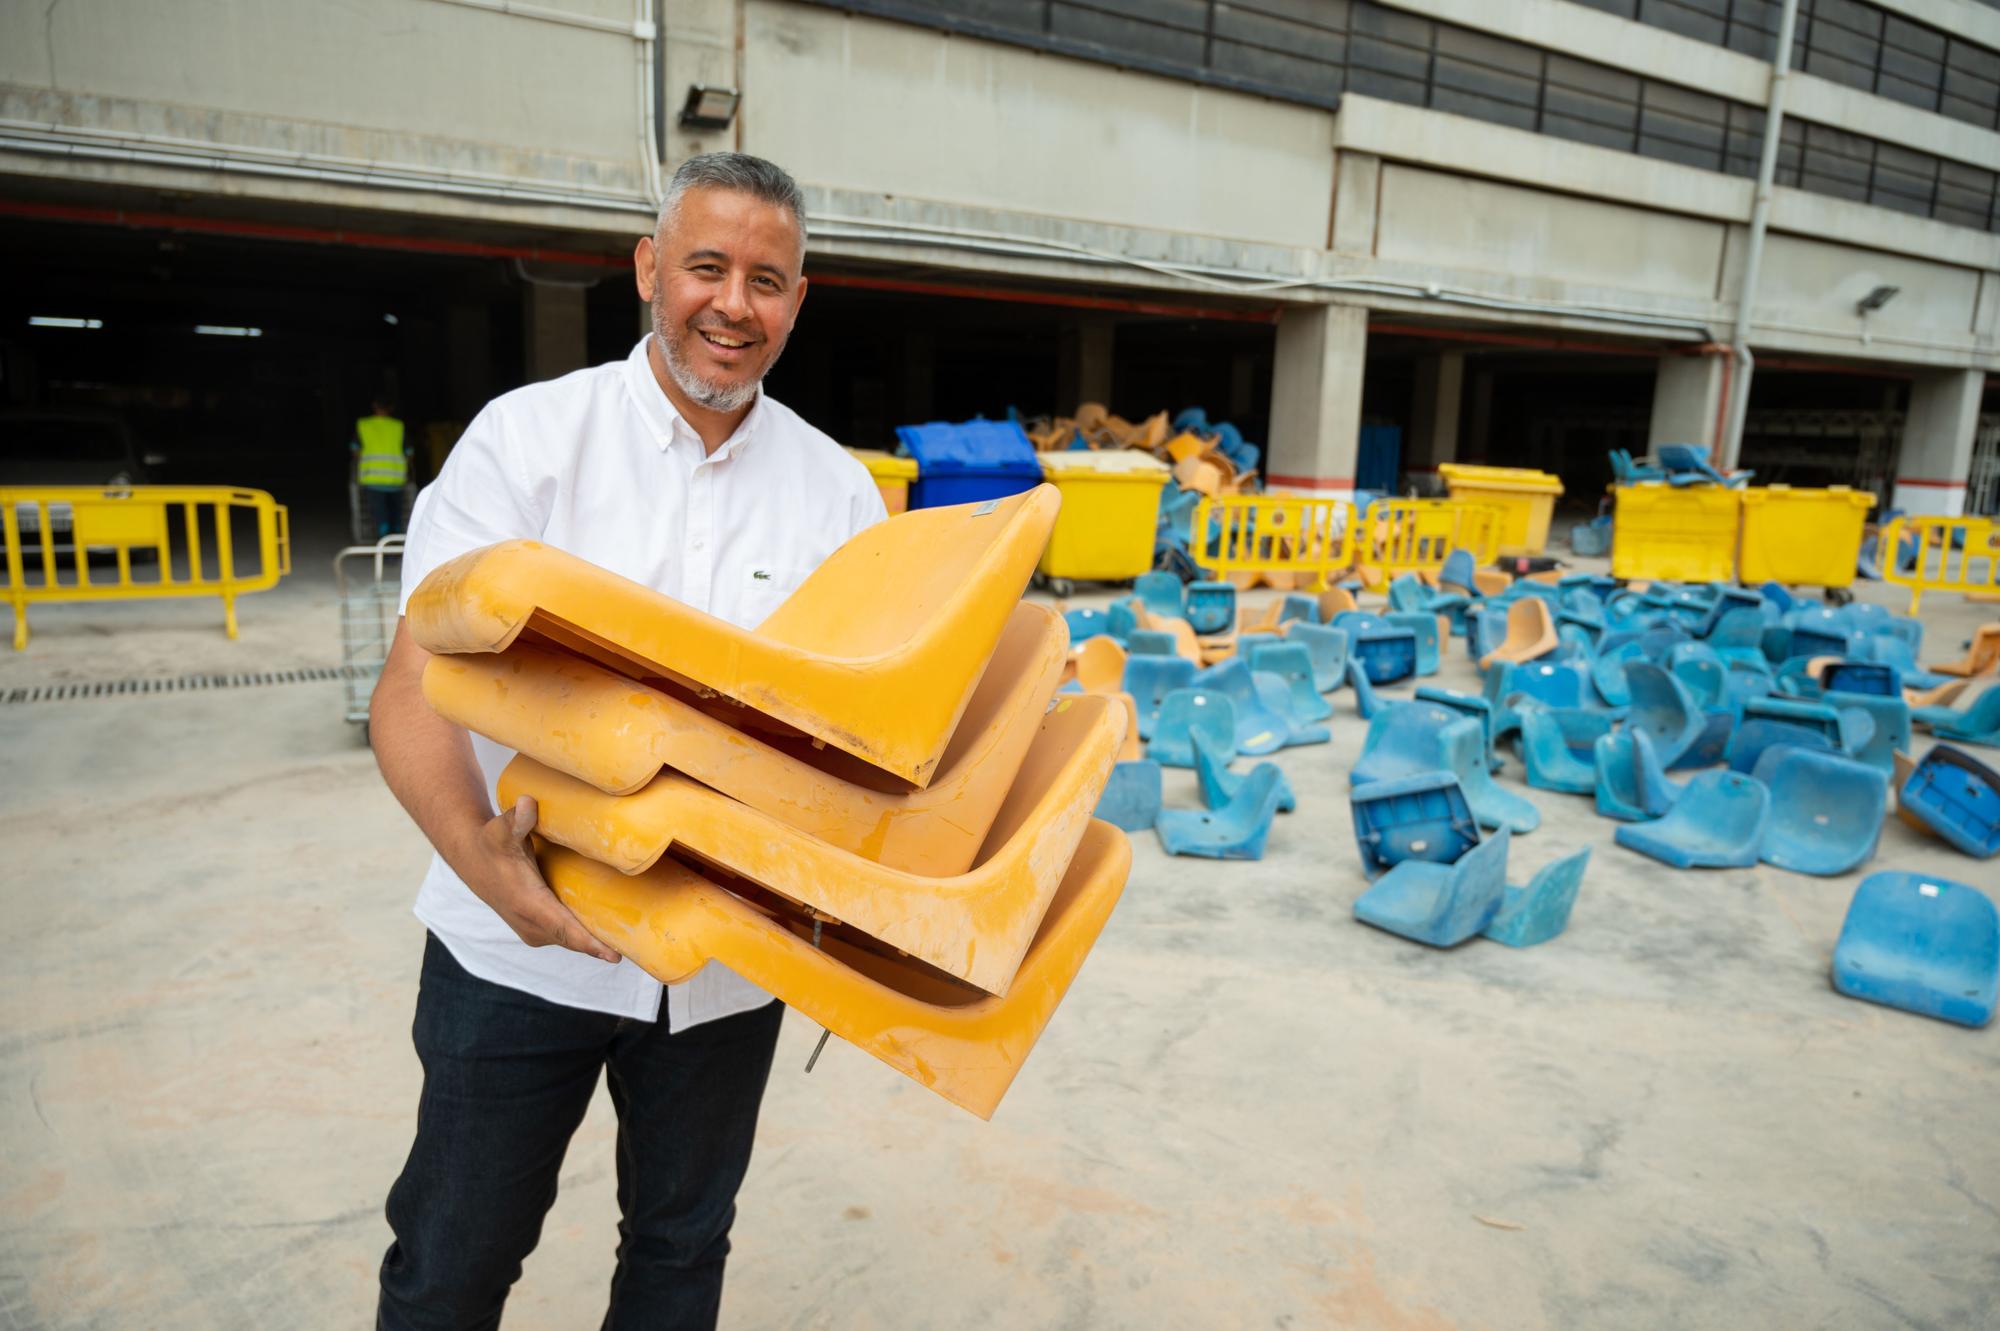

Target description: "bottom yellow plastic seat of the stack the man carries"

left=542, top=821, right=1132, bottom=1119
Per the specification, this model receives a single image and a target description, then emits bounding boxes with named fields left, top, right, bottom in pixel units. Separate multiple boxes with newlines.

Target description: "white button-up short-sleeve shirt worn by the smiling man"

left=402, top=338, right=886, bottom=1029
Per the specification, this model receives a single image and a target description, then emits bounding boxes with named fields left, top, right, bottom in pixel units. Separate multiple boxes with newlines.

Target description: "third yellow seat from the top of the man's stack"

left=500, top=693, right=1126, bottom=993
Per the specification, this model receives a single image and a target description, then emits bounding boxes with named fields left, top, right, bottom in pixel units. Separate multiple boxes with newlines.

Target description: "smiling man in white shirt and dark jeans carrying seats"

left=370, top=154, right=884, bottom=1331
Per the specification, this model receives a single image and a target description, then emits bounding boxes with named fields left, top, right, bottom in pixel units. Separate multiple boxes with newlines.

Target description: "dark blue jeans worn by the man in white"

left=376, top=937, right=784, bottom=1331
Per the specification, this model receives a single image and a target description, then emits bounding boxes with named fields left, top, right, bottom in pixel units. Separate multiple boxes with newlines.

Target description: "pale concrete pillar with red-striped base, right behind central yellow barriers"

left=1264, top=306, right=1368, bottom=494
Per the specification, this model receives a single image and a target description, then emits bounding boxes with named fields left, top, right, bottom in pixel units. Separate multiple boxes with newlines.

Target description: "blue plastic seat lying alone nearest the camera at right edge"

left=1834, top=869, right=2000, bottom=1029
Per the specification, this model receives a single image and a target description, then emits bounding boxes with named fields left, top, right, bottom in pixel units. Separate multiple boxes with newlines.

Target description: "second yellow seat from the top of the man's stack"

left=424, top=602, right=1068, bottom=877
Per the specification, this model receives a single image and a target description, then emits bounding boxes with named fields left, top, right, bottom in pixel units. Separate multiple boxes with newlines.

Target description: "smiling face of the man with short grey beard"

left=634, top=190, right=806, bottom=412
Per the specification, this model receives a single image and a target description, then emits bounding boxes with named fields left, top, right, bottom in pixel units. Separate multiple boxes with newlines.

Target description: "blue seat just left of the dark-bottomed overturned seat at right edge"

left=1754, top=745, right=1888, bottom=877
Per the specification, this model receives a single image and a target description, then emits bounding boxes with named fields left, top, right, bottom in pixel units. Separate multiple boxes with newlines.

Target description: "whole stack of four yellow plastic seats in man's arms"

left=408, top=486, right=1130, bottom=1117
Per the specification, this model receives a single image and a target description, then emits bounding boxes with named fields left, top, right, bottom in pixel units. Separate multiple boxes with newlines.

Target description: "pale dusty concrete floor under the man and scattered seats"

left=0, top=519, right=2000, bottom=1331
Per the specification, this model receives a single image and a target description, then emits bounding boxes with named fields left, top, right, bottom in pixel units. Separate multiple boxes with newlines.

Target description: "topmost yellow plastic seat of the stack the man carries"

left=408, top=486, right=1060, bottom=785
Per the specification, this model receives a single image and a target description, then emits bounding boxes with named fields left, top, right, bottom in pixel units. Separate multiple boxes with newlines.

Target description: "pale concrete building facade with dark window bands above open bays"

left=0, top=0, right=2000, bottom=514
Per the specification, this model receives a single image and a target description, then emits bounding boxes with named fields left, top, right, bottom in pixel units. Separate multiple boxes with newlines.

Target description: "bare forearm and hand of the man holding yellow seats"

left=368, top=620, right=618, bottom=963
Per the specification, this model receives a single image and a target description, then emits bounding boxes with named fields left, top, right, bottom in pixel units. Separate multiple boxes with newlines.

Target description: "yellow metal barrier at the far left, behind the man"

left=0, top=486, right=292, bottom=652
